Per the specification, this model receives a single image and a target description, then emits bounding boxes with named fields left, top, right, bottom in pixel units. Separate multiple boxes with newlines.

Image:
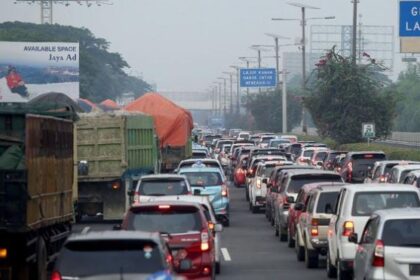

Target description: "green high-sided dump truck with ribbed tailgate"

left=76, top=111, right=159, bottom=220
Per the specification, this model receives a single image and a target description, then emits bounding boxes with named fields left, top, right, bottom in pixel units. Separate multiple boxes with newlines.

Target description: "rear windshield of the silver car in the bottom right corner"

left=382, top=219, right=420, bottom=248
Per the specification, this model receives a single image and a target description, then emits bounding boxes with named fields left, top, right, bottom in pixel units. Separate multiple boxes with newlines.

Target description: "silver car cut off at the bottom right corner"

left=349, top=208, right=420, bottom=280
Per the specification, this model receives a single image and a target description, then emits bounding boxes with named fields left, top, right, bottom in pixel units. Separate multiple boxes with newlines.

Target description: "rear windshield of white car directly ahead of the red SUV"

left=139, top=180, right=189, bottom=196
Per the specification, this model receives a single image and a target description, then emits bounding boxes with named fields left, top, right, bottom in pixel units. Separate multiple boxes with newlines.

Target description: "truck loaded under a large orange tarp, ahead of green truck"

left=124, top=92, right=194, bottom=172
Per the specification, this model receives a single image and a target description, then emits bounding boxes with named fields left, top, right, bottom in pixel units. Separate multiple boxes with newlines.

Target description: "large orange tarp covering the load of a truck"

left=124, top=92, right=193, bottom=147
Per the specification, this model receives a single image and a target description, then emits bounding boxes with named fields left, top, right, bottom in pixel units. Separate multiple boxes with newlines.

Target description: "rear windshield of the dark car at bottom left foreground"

left=57, top=240, right=165, bottom=277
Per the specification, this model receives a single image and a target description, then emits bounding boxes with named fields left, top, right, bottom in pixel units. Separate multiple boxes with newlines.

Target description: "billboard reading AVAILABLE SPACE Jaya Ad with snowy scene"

left=0, top=42, right=79, bottom=102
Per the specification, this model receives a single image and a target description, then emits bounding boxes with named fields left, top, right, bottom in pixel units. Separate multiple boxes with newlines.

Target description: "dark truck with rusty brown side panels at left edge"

left=0, top=110, right=74, bottom=280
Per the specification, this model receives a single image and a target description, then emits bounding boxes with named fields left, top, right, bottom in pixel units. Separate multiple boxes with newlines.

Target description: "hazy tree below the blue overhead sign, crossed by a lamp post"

left=247, top=90, right=302, bottom=132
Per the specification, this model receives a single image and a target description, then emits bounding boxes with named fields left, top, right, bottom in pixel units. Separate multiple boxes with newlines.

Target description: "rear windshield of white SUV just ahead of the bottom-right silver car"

left=352, top=192, right=420, bottom=216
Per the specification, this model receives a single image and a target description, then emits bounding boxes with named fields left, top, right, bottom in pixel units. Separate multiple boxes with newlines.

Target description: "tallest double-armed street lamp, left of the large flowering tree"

left=272, top=0, right=334, bottom=134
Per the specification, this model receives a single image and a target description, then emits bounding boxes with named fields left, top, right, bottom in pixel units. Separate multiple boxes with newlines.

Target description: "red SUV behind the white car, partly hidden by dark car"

left=121, top=201, right=215, bottom=279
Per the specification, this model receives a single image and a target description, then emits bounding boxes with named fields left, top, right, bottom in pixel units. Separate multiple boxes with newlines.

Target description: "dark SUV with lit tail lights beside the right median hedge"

left=340, top=151, right=386, bottom=183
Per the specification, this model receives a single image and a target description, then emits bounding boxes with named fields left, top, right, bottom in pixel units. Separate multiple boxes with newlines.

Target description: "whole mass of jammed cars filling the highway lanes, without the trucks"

left=50, top=128, right=420, bottom=280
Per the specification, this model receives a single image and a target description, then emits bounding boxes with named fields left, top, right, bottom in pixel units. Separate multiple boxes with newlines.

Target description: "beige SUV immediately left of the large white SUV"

left=289, top=183, right=343, bottom=268
